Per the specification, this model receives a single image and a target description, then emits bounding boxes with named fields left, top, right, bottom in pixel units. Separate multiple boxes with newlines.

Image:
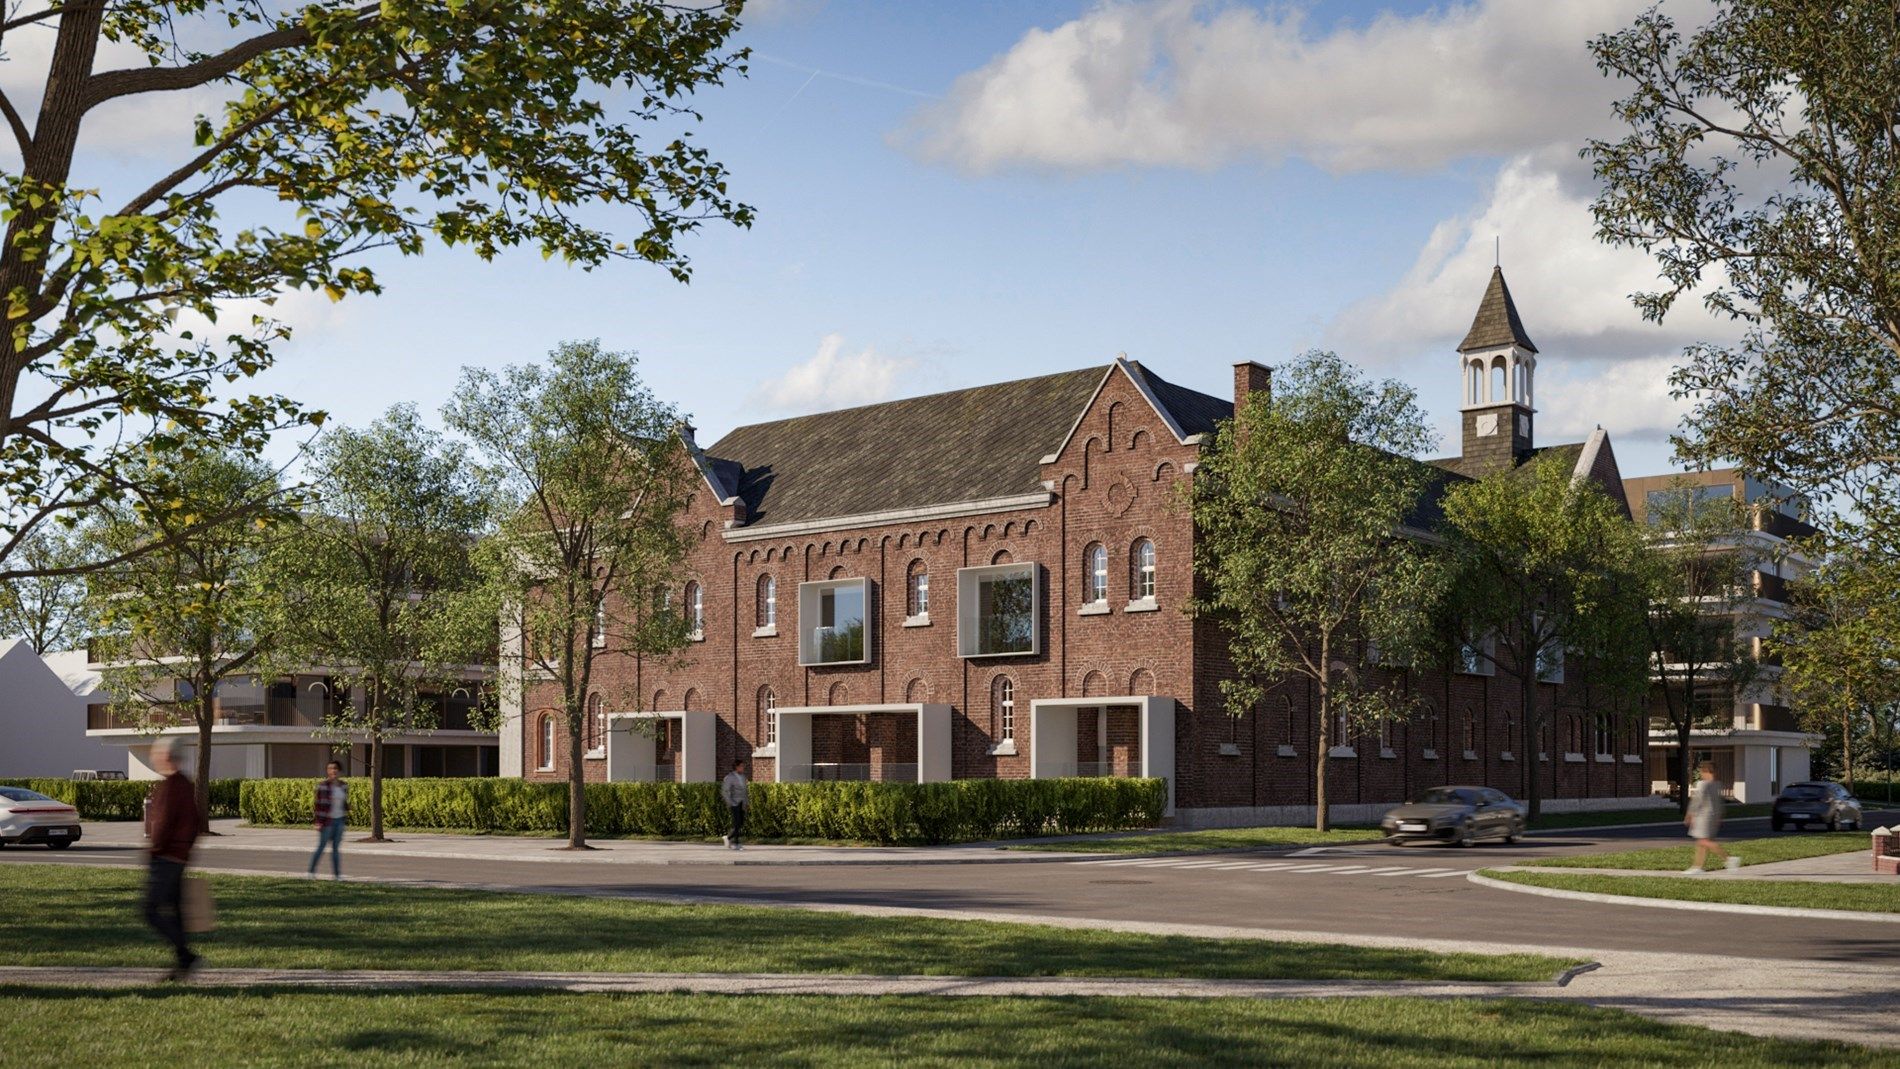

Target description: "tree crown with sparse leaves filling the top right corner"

left=1585, top=0, right=1900, bottom=553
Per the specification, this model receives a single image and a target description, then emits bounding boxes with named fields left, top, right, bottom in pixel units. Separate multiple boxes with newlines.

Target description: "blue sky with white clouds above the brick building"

left=100, top=0, right=1712, bottom=475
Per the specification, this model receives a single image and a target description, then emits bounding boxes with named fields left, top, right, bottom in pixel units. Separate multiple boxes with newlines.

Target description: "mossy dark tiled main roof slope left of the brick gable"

left=707, top=366, right=1108, bottom=524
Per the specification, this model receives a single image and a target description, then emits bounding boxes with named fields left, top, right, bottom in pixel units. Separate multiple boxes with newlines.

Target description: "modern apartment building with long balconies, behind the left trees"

left=86, top=641, right=500, bottom=778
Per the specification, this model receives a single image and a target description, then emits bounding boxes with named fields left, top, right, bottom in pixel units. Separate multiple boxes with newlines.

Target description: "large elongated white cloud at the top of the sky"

left=897, top=0, right=1647, bottom=173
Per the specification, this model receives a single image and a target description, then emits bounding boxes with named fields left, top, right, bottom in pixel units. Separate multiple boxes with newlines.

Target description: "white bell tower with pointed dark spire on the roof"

left=1457, top=268, right=1537, bottom=475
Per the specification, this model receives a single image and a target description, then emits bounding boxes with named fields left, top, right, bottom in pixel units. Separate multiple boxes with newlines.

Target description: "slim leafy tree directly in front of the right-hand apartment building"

left=1644, top=482, right=1767, bottom=811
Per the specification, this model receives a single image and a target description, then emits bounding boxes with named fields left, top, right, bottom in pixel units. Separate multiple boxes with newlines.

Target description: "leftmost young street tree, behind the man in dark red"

left=91, top=456, right=295, bottom=813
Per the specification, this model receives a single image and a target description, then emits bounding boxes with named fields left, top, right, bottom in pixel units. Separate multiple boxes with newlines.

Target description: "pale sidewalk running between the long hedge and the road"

left=78, top=820, right=1115, bottom=870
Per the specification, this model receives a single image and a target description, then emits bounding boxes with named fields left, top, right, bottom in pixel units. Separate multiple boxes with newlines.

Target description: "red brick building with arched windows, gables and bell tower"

left=504, top=273, right=1649, bottom=822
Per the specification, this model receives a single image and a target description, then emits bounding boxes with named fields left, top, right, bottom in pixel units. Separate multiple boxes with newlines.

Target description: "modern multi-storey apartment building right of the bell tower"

left=1623, top=467, right=1818, bottom=801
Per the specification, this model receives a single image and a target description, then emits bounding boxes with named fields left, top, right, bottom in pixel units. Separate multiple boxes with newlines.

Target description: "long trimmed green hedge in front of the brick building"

left=238, top=777, right=1167, bottom=843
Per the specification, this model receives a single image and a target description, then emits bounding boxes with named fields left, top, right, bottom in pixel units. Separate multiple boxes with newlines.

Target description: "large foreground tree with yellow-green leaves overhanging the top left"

left=0, top=0, right=752, bottom=579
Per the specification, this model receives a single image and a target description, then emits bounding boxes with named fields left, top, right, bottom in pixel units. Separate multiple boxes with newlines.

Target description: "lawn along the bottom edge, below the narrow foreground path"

left=0, top=989, right=1892, bottom=1069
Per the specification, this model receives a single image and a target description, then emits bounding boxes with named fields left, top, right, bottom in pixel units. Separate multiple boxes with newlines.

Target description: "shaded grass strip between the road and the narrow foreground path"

left=0, top=864, right=1575, bottom=980
